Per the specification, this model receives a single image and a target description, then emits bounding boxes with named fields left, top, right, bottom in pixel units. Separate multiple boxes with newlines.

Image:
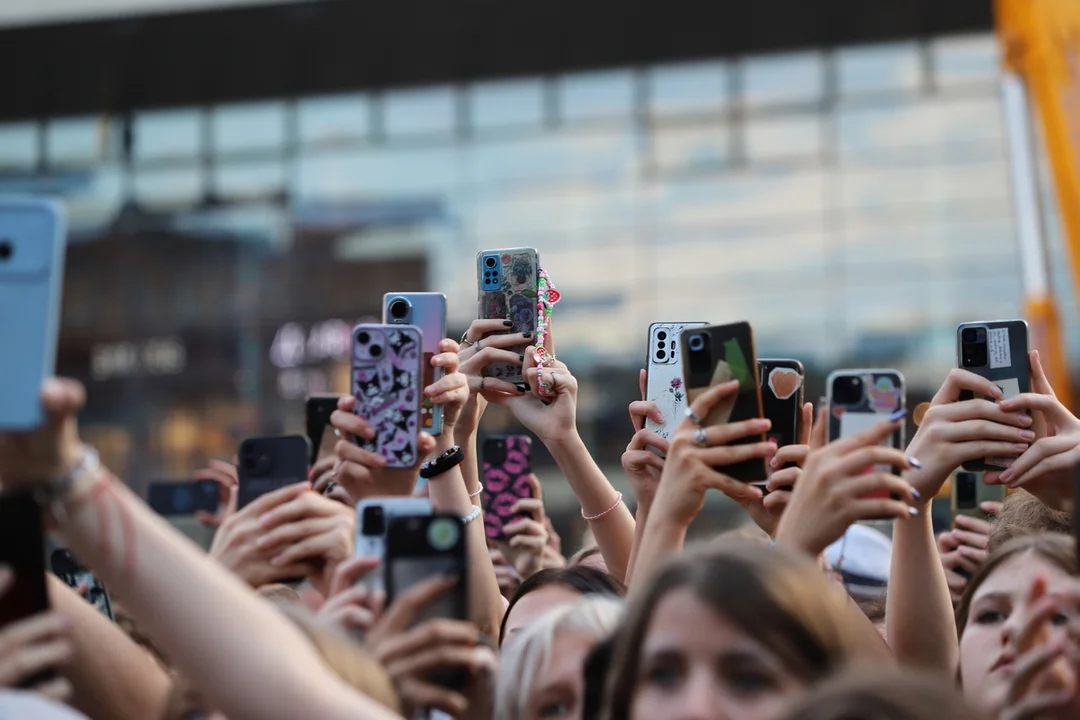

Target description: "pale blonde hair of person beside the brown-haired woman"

left=492, top=596, right=623, bottom=720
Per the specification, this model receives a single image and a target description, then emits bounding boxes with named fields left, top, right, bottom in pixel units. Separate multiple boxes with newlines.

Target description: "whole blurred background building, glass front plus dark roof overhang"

left=0, top=0, right=1075, bottom=544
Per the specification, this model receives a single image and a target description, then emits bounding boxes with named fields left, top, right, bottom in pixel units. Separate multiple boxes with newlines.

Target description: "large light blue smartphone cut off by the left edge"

left=0, top=195, right=67, bottom=431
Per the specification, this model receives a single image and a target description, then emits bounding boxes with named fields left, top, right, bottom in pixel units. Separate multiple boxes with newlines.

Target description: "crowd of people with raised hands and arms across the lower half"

left=0, top=302, right=1080, bottom=720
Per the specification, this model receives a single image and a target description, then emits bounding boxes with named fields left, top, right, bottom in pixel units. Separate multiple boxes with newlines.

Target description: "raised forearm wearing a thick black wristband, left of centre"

left=428, top=433, right=502, bottom=638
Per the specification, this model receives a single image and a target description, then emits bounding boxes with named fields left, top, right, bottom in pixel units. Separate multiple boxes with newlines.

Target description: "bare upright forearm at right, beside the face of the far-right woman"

left=886, top=498, right=959, bottom=674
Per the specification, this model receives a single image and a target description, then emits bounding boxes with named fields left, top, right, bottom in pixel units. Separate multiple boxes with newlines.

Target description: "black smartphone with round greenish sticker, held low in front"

left=386, top=515, right=469, bottom=689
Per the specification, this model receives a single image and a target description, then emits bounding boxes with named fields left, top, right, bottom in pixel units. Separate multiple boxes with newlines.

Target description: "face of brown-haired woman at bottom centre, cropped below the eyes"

left=631, top=589, right=806, bottom=720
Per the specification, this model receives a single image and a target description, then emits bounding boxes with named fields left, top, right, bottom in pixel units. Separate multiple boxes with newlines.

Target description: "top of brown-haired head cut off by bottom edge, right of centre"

left=784, top=673, right=985, bottom=720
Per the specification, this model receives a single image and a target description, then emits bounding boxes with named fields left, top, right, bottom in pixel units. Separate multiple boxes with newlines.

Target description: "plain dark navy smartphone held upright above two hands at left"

left=233, top=435, right=311, bottom=508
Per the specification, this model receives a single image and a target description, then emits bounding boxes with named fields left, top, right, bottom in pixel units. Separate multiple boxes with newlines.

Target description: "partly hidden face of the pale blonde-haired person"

left=525, top=633, right=596, bottom=720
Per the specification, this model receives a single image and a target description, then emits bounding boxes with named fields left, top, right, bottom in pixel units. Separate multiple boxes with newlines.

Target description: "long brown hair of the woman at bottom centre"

left=607, top=539, right=891, bottom=720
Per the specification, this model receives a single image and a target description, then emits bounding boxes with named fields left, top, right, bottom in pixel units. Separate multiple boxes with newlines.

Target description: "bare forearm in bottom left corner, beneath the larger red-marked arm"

left=48, top=575, right=172, bottom=720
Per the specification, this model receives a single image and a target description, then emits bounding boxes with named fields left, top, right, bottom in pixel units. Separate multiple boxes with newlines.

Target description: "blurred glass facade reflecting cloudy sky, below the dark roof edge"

left=0, top=35, right=1041, bottom=535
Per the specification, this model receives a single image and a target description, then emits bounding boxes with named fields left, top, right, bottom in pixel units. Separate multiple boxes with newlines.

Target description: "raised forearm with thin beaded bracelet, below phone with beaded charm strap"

left=548, top=434, right=634, bottom=580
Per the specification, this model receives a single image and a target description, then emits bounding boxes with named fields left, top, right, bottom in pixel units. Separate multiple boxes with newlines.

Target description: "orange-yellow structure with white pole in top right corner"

left=995, top=0, right=1080, bottom=408
